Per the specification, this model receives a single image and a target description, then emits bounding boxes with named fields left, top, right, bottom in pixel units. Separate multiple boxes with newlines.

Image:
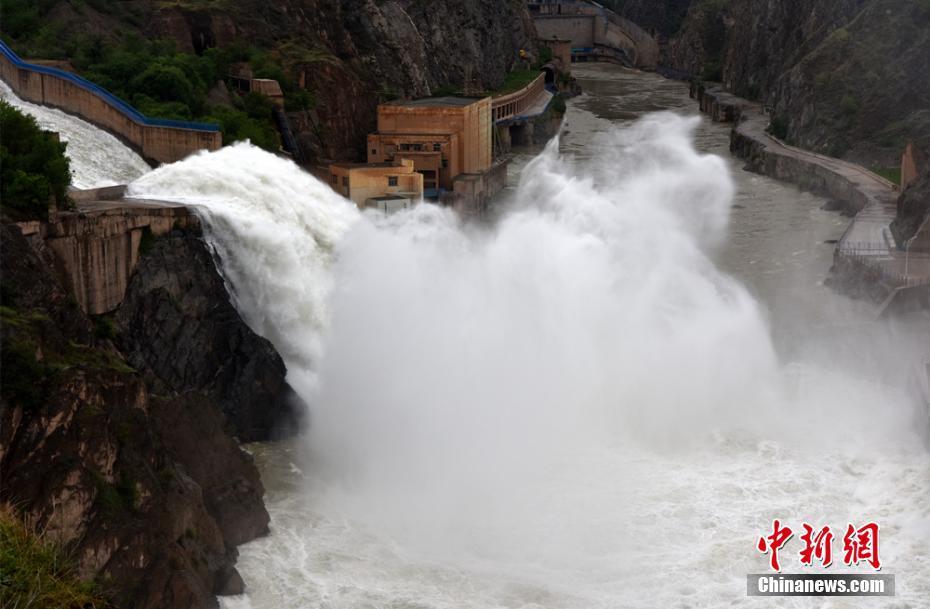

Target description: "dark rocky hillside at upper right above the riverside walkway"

left=667, top=0, right=930, bottom=167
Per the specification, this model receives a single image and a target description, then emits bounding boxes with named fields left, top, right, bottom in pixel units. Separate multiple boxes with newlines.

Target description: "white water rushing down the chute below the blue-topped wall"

left=0, top=80, right=152, bottom=188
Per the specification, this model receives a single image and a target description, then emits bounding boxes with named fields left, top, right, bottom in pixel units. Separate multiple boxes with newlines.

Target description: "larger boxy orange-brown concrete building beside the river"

left=368, top=97, right=493, bottom=196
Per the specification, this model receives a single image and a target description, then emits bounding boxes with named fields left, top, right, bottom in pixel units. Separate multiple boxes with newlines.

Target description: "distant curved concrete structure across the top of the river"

left=527, top=0, right=659, bottom=70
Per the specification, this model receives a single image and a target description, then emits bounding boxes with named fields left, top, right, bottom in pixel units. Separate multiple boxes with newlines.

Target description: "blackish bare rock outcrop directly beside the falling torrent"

left=116, top=229, right=299, bottom=441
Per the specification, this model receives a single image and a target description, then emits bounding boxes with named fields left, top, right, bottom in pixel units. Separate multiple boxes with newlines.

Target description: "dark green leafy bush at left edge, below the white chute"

left=0, top=100, right=71, bottom=220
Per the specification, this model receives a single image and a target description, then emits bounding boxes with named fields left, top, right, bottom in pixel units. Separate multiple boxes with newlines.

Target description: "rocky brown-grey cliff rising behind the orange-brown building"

left=23, top=0, right=535, bottom=161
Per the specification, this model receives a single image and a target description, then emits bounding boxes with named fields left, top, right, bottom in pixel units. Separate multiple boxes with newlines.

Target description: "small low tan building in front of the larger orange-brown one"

left=329, top=159, right=423, bottom=211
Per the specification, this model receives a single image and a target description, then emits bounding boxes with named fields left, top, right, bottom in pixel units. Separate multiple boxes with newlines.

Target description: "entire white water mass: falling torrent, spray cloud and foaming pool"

left=131, top=109, right=930, bottom=609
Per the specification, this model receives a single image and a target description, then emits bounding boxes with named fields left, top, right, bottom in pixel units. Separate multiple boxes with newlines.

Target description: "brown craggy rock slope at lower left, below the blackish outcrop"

left=0, top=224, right=272, bottom=609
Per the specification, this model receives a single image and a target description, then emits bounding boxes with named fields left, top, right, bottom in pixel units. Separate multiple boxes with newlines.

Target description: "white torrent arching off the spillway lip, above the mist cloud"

left=127, top=142, right=360, bottom=392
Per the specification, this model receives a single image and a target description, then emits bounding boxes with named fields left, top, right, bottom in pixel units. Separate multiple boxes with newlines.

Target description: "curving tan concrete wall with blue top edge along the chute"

left=0, top=41, right=223, bottom=163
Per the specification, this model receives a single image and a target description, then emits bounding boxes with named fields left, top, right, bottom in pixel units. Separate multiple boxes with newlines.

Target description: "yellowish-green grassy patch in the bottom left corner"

left=0, top=509, right=107, bottom=609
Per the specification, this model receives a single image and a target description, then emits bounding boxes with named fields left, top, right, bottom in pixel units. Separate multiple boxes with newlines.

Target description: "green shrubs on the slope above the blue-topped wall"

left=0, top=8, right=333, bottom=151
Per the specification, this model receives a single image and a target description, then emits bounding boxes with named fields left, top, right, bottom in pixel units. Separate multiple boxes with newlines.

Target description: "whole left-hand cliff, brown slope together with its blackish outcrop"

left=0, top=217, right=289, bottom=609
